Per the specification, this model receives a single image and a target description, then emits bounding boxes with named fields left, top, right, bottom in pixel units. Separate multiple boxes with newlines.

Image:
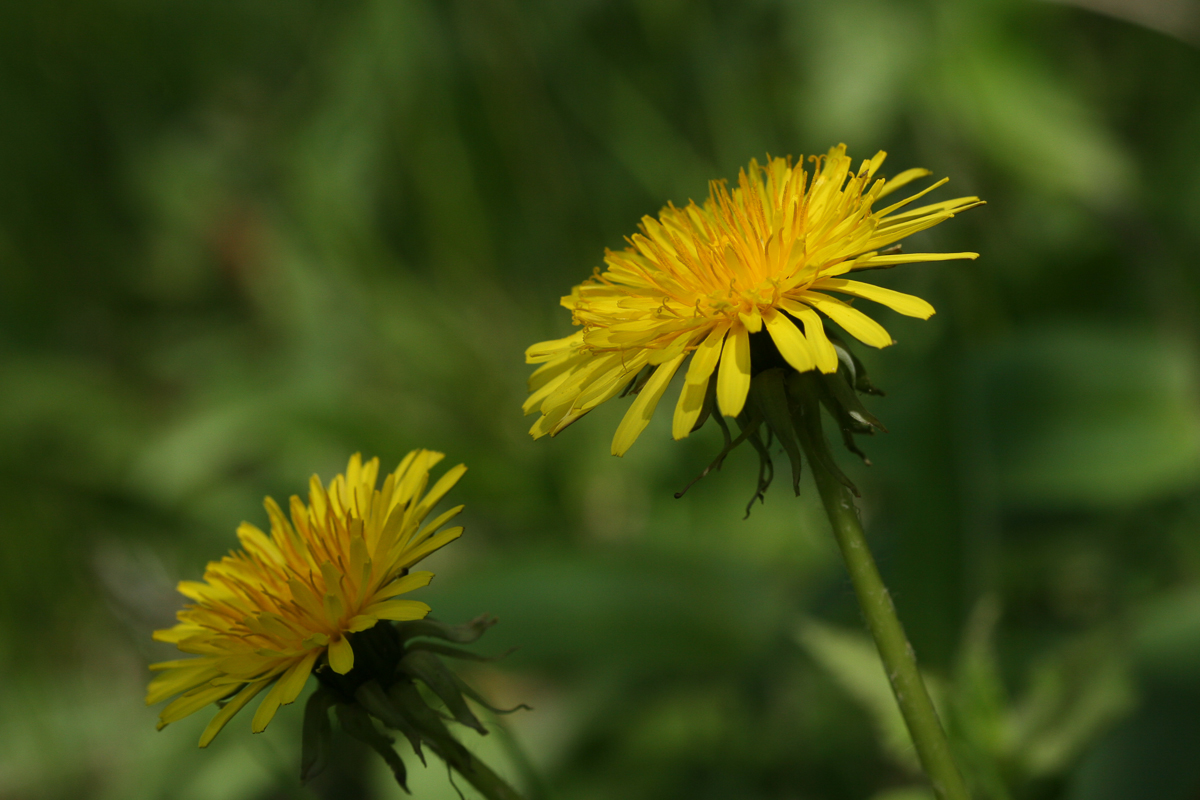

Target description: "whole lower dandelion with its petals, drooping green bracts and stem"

left=146, top=450, right=523, bottom=800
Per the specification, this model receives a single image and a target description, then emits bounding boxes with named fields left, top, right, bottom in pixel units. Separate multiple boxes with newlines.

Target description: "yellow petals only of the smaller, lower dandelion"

left=146, top=450, right=467, bottom=747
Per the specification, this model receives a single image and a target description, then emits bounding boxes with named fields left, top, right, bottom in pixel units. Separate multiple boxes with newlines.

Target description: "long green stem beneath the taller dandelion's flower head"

left=810, top=462, right=970, bottom=800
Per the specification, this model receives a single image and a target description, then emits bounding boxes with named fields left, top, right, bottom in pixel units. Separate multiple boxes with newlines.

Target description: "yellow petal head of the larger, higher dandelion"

left=524, top=145, right=980, bottom=456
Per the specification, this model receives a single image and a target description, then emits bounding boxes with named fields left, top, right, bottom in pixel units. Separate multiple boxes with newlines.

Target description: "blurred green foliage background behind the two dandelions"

left=0, top=0, right=1200, bottom=800
